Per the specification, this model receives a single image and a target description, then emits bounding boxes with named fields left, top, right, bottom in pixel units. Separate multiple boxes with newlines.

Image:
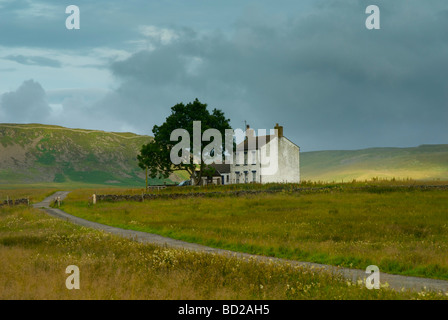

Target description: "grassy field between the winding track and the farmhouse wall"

left=62, top=182, right=448, bottom=279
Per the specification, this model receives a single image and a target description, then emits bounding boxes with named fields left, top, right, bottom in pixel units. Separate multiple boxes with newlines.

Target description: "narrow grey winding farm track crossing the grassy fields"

left=33, top=191, right=448, bottom=293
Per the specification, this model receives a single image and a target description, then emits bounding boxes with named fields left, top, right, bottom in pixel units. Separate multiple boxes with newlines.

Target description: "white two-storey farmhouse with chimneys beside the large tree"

left=230, top=123, right=300, bottom=183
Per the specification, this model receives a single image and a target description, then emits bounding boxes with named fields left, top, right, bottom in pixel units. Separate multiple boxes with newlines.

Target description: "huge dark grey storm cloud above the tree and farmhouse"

left=101, top=1, right=448, bottom=150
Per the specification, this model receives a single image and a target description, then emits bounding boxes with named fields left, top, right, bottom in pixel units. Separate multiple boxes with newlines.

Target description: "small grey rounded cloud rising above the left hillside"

left=0, top=80, right=51, bottom=123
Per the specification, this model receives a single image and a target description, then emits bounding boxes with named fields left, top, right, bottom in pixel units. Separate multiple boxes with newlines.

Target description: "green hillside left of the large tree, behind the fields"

left=0, top=124, right=178, bottom=186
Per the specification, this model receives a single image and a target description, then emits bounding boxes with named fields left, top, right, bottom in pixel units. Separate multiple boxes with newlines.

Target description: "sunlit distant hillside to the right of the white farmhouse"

left=301, top=144, right=448, bottom=181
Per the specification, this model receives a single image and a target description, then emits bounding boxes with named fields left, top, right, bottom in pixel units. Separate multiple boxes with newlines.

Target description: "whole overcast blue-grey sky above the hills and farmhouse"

left=0, top=0, right=448, bottom=151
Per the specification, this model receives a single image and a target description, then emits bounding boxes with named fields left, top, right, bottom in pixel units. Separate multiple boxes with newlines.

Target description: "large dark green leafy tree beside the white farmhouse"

left=138, top=99, right=232, bottom=184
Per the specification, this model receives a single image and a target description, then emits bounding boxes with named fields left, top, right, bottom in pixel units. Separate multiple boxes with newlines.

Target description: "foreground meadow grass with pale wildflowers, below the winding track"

left=0, top=206, right=448, bottom=299
